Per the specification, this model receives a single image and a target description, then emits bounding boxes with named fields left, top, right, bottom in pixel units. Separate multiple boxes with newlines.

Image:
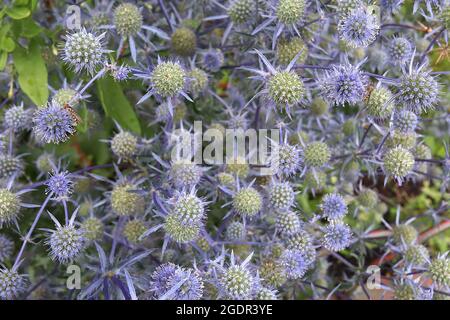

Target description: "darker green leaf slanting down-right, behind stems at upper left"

left=97, top=76, right=141, bottom=134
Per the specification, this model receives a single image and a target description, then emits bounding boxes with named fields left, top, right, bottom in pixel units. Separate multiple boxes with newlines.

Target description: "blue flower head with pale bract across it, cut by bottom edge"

left=151, top=263, right=203, bottom=300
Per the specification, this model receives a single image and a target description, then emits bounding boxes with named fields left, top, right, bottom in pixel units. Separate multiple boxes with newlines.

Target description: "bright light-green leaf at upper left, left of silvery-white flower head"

left=13, top=40, right=48, bottom=106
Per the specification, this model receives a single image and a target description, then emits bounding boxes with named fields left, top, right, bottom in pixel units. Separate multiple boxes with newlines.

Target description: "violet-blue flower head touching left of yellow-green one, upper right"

left=320, top=63, right=367, bottom=105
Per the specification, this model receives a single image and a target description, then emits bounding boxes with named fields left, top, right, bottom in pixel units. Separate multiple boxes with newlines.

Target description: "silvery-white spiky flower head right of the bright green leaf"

left=63, top=29, right=105, bottom=74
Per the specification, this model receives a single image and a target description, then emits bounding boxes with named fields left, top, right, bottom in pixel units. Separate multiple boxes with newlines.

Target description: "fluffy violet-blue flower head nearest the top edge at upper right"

left=338, top=7, right=380, bottom=47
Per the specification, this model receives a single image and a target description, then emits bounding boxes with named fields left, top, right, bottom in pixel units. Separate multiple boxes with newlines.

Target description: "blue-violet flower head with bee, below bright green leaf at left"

left=33, top=103, right=76, bottom=144
